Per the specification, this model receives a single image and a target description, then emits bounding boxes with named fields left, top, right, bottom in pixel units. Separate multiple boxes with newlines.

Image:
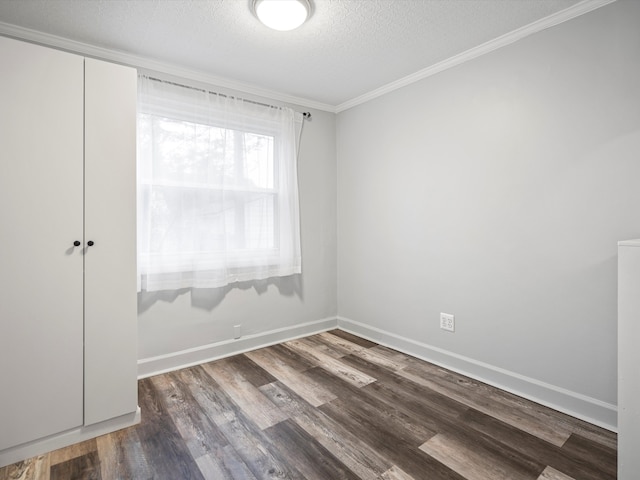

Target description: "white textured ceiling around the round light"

left=0, top=0, right=592, bottom=106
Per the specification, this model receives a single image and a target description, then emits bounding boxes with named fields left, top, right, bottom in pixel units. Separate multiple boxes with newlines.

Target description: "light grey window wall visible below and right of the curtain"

left=138, top=100, right=337, bottom=368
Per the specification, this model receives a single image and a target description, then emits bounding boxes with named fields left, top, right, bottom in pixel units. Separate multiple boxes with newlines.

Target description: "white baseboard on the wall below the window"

left=138, top=317, right=338, bottom=379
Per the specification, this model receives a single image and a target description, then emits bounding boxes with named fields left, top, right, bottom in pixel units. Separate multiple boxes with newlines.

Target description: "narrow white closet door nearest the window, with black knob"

left=85, top=59, right=138, bottom=425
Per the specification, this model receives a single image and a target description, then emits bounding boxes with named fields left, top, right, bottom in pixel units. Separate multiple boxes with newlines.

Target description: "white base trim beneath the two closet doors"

left=0, top=407, right=140, bottom=468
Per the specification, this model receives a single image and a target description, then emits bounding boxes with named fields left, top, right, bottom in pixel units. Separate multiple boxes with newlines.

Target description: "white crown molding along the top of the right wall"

left=335, top=0, right=616, bottom=113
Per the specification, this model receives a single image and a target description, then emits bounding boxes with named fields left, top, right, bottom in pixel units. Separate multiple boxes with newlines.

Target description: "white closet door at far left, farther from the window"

left=0, top=37, right=84, bottom=450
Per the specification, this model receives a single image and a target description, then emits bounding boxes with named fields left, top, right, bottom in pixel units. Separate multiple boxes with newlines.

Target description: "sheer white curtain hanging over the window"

left=138, top=76, right=302, bottom=291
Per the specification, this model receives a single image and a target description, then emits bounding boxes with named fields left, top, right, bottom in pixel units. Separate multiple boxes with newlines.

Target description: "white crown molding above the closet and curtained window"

left=0, top=22, right=336, bottom=113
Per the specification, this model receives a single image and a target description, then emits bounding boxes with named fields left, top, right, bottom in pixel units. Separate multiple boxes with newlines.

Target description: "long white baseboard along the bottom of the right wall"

left=338, top=317, right=618, bottom=432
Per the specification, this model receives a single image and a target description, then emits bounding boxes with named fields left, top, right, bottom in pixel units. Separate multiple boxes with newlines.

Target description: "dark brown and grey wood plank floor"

left=0, top=331, right=616, bottom=480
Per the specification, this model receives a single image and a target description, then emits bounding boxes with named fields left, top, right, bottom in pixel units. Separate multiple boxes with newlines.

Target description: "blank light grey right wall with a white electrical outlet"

left=337, top=0, right=640, bottom=424
